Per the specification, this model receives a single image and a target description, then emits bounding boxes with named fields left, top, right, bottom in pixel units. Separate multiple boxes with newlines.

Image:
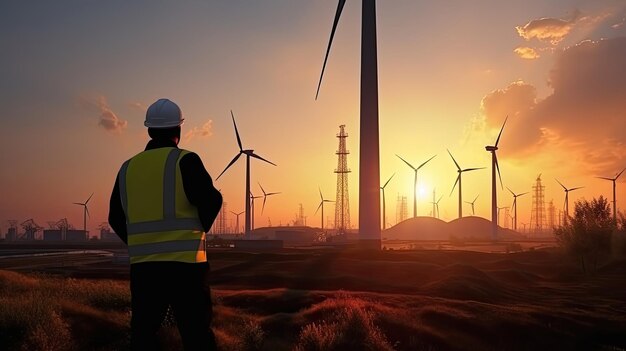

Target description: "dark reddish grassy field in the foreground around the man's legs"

left=0, top=250, right=626, bottom=350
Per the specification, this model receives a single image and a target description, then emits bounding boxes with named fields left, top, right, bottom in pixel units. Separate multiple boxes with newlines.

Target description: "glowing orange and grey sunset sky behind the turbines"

left=0, top=0, right=626, bottom=233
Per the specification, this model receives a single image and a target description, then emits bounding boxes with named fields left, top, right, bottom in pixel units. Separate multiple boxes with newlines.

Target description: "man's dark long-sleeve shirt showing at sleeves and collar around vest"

left=109, top=139, right=222, bottom=243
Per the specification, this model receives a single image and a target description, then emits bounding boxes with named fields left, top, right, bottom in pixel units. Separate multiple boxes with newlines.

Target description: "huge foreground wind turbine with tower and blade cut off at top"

left=315, top=0, right=380, bottom=250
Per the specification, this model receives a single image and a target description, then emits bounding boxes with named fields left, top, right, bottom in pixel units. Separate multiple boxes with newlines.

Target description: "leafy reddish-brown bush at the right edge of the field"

left=554, top=196, right=615, bottom=272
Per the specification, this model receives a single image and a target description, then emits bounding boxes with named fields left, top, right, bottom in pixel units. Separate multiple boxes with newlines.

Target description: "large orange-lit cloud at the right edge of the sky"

left=481, top=37, right=626, bottom=174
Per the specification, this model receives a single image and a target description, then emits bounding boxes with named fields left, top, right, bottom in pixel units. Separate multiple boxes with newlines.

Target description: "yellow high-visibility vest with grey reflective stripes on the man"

left=118, top=147, right=206, bottom=264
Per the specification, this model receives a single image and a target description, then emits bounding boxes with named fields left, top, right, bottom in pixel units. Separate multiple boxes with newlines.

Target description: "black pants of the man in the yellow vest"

left=130, top=262, right=217, bottom=351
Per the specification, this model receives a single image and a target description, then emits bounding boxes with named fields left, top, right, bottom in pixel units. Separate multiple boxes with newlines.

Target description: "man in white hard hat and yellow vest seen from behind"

left=109, top=99, right=222, bottom=350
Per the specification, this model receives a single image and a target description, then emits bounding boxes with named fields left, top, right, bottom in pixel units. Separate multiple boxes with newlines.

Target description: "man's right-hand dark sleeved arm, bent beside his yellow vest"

left=180, top=152, right=222, bottom=232
